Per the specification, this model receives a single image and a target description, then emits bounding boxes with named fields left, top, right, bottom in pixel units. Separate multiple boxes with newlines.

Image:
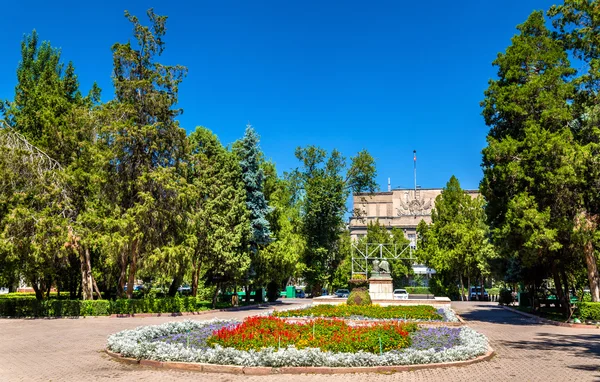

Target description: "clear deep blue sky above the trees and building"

left=0, top=0, right=553, bottom=189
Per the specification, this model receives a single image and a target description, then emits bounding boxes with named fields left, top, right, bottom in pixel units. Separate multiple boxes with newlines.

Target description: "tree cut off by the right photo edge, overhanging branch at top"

left=548, top=0, right=600, bottom=301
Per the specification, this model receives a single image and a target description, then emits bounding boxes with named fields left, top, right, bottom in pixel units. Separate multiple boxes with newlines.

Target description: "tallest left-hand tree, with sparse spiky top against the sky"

left=98, top=9, right=186, bottom=298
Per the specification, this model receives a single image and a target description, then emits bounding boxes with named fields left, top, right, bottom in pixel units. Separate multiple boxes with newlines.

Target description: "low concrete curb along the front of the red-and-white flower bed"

left=105, top=346, right=495, bottom=375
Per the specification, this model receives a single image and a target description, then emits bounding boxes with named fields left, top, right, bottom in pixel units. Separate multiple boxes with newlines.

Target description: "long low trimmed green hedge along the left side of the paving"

left=0, top=297, right=229, bottom=317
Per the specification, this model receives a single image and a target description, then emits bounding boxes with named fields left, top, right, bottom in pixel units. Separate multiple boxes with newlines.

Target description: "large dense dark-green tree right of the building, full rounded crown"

left=481, top=12, right=595, bottom=307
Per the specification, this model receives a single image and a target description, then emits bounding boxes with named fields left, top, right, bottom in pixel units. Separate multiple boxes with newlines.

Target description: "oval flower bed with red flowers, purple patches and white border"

left=107, top=317, right=488, bottom=367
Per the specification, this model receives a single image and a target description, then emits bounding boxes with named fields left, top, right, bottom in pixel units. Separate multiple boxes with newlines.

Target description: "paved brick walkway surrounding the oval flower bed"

left=0, top=300, right=600, bottom=382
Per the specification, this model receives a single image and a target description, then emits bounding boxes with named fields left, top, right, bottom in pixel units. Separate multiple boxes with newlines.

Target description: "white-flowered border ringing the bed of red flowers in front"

left=107, top=320, right=488, bottom=367
